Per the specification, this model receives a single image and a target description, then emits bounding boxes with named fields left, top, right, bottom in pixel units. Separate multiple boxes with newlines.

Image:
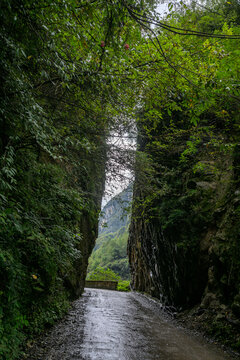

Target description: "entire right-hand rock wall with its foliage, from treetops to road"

left=130, top=2, right=240, bottom=348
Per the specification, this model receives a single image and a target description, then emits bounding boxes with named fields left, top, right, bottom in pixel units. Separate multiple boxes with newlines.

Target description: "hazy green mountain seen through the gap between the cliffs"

left=88, top=185, right=132, bottom=279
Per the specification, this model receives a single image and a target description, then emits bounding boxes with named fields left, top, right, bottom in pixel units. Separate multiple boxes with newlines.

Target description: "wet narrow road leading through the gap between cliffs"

left=24, top=289, right=236, bottom=360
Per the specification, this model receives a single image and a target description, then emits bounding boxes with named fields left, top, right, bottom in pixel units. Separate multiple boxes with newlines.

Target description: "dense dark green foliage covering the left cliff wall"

left=0, top=0, right=144, bottom=359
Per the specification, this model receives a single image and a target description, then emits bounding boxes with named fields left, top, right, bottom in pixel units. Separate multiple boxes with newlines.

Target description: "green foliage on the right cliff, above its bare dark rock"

left=131, top=0, right=240, bottom=294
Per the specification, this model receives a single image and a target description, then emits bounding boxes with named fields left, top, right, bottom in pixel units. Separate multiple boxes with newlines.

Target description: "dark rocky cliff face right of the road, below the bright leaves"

left=128, top=121, right=240, bottom=348
